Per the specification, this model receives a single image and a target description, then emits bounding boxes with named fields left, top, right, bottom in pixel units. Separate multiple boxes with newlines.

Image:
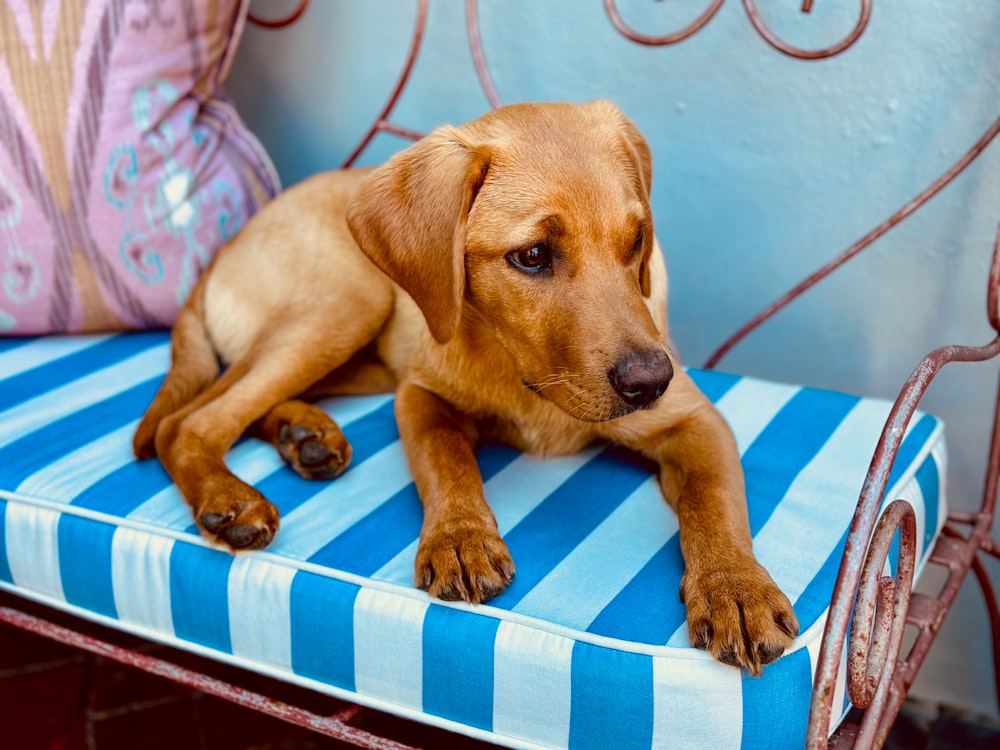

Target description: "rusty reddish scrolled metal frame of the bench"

left=0, top=0, right=1000, bottom=750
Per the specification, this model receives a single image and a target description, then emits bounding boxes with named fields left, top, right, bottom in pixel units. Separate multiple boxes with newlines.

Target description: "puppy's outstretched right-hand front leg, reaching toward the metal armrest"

left=620, top=373, right=799, bottom=675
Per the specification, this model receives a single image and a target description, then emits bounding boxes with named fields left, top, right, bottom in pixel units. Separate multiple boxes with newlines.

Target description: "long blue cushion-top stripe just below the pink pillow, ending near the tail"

left=0, top=331, right=168, bottom=413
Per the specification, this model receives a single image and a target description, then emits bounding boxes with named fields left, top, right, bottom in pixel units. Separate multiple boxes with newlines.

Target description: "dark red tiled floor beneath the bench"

left=0, top=592, right=1000, bottom=750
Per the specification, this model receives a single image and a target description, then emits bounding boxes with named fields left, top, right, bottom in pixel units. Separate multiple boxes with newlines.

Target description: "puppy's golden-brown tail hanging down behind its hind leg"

left=132, top=285, right=219, bottom=459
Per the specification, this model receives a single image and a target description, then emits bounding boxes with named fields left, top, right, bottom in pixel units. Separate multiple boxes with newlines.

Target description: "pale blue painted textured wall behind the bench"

left=227, top=0, right=1000, bottom=715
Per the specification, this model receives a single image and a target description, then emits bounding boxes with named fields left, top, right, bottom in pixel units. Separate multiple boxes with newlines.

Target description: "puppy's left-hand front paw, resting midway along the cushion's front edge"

left=416, top=524, right=514, bottom=604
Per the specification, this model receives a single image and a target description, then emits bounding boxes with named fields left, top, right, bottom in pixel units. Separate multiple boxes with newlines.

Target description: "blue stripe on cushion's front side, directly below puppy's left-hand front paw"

left=422, top=605, right=500, bottom=730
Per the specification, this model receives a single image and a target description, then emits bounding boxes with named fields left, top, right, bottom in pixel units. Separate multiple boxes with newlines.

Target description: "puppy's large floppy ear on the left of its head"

left=347, top=127, right=489, bottom=344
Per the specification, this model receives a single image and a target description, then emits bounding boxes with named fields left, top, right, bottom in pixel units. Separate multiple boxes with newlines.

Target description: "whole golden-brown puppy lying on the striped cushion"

left=135, top=102, right=798, bottom=673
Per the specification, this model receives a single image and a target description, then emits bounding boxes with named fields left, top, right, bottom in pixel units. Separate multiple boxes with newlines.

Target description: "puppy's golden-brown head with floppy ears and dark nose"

left=347, top=101, right=673, bottom=421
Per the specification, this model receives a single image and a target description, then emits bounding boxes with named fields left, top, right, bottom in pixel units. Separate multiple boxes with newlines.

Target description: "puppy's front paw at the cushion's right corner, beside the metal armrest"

left=681, top=559, right=799, bottom=676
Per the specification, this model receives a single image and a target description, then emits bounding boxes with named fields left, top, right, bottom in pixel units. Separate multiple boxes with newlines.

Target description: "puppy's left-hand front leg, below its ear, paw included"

left=396, top=383, right=514, bottom=603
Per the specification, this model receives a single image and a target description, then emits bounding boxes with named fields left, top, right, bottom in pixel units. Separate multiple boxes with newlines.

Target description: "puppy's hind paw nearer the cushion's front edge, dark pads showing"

left=195, top=478, right=280, bottom=551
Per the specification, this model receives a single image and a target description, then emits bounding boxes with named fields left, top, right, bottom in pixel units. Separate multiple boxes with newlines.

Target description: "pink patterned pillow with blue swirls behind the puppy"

left=0, top=0, right=278, bottom=334
